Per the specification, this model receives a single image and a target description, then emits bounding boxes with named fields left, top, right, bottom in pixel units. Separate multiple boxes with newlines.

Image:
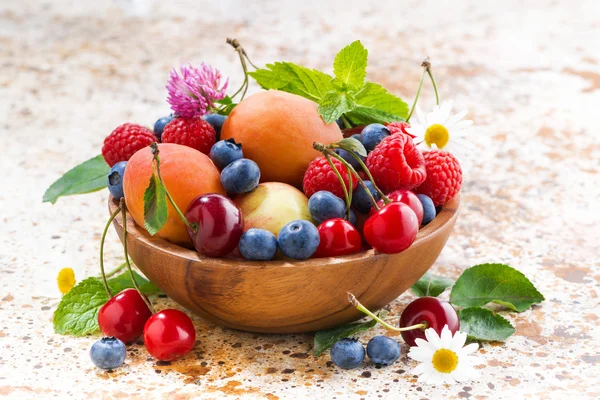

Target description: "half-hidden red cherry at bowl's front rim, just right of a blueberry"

left=314, top=218, right=362, bottom=257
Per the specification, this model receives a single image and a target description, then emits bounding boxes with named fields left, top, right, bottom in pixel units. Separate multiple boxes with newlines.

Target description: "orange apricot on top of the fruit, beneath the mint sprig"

left=221, top=90, right=342, bottom=187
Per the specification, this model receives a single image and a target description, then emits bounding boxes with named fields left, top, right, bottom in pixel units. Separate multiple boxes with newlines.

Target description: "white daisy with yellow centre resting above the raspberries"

left=406, top=102, right=473, bottom=156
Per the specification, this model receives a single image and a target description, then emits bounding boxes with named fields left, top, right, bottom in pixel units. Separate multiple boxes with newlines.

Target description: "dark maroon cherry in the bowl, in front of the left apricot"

left=185, top=193, right=244, bottom=257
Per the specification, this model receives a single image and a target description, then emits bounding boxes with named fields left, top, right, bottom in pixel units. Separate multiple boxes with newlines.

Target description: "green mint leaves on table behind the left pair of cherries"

left=53, top=271, right=160, bottom=336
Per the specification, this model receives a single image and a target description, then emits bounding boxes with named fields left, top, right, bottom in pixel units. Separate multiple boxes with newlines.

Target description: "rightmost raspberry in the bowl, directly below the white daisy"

left=415, top=150, right=462, bottom=206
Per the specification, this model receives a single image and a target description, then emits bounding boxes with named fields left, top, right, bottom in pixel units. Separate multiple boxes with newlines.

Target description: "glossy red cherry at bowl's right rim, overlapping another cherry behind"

left=363, top=202, right=419, bottom=254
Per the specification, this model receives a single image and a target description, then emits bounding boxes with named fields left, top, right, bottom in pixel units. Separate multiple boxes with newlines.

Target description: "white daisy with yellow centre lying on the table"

left=408, top=325, right=479, bottom=385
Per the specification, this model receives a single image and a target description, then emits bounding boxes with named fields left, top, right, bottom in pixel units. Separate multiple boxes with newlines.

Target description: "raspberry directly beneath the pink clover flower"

left=162, top=117, right=217, bottom=154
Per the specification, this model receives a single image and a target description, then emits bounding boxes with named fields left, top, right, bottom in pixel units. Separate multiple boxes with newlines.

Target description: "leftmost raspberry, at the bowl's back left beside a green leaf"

left=102, top=124, right=156, bottom=167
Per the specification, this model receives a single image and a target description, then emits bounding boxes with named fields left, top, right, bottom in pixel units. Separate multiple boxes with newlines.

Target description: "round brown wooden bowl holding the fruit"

left=109, top=198, right=460, bottom=333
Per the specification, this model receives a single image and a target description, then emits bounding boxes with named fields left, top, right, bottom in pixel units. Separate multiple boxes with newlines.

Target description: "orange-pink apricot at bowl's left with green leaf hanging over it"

left=123, top=143, right=225, bottom=247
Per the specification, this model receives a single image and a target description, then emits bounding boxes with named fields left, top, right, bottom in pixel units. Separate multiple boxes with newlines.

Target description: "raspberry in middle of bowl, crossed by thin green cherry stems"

left=302, top=156, right=358, bottom=200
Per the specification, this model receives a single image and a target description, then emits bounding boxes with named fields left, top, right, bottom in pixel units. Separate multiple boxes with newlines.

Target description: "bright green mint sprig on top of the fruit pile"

left=248, top=40, right=408, bottom=125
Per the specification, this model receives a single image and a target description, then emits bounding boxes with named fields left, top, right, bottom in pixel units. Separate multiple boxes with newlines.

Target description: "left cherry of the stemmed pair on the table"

left=98, top=289, right=152, bottom=343
